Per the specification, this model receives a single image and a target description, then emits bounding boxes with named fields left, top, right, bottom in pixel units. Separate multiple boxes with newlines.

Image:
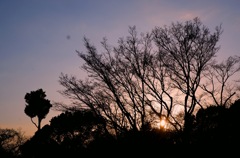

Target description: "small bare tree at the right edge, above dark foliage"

left=201, top=56, right=240, bottom=107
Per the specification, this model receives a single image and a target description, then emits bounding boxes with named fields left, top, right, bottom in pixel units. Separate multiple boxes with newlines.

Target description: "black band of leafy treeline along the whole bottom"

left=0, top=100, right=240, bottom=158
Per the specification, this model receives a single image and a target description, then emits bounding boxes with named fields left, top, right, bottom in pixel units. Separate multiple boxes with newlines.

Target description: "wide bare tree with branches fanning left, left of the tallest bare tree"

left=57, top=27, right=157, bottom=133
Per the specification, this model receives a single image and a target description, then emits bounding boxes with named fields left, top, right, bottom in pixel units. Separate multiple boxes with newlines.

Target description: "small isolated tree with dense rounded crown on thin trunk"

left=24, top=89, right=52, bottom=130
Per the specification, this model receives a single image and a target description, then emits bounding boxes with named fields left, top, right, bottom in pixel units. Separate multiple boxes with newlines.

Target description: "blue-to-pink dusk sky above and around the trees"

left=0, top=0, right=240, bottom=136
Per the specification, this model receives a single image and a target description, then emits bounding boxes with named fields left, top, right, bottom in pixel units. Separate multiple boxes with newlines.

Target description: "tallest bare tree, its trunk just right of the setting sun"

left=153, top=17, right=222, bottom=130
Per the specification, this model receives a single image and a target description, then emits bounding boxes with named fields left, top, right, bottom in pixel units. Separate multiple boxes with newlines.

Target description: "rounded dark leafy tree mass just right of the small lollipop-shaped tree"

left=21, top=110, right=113, bottom=158
